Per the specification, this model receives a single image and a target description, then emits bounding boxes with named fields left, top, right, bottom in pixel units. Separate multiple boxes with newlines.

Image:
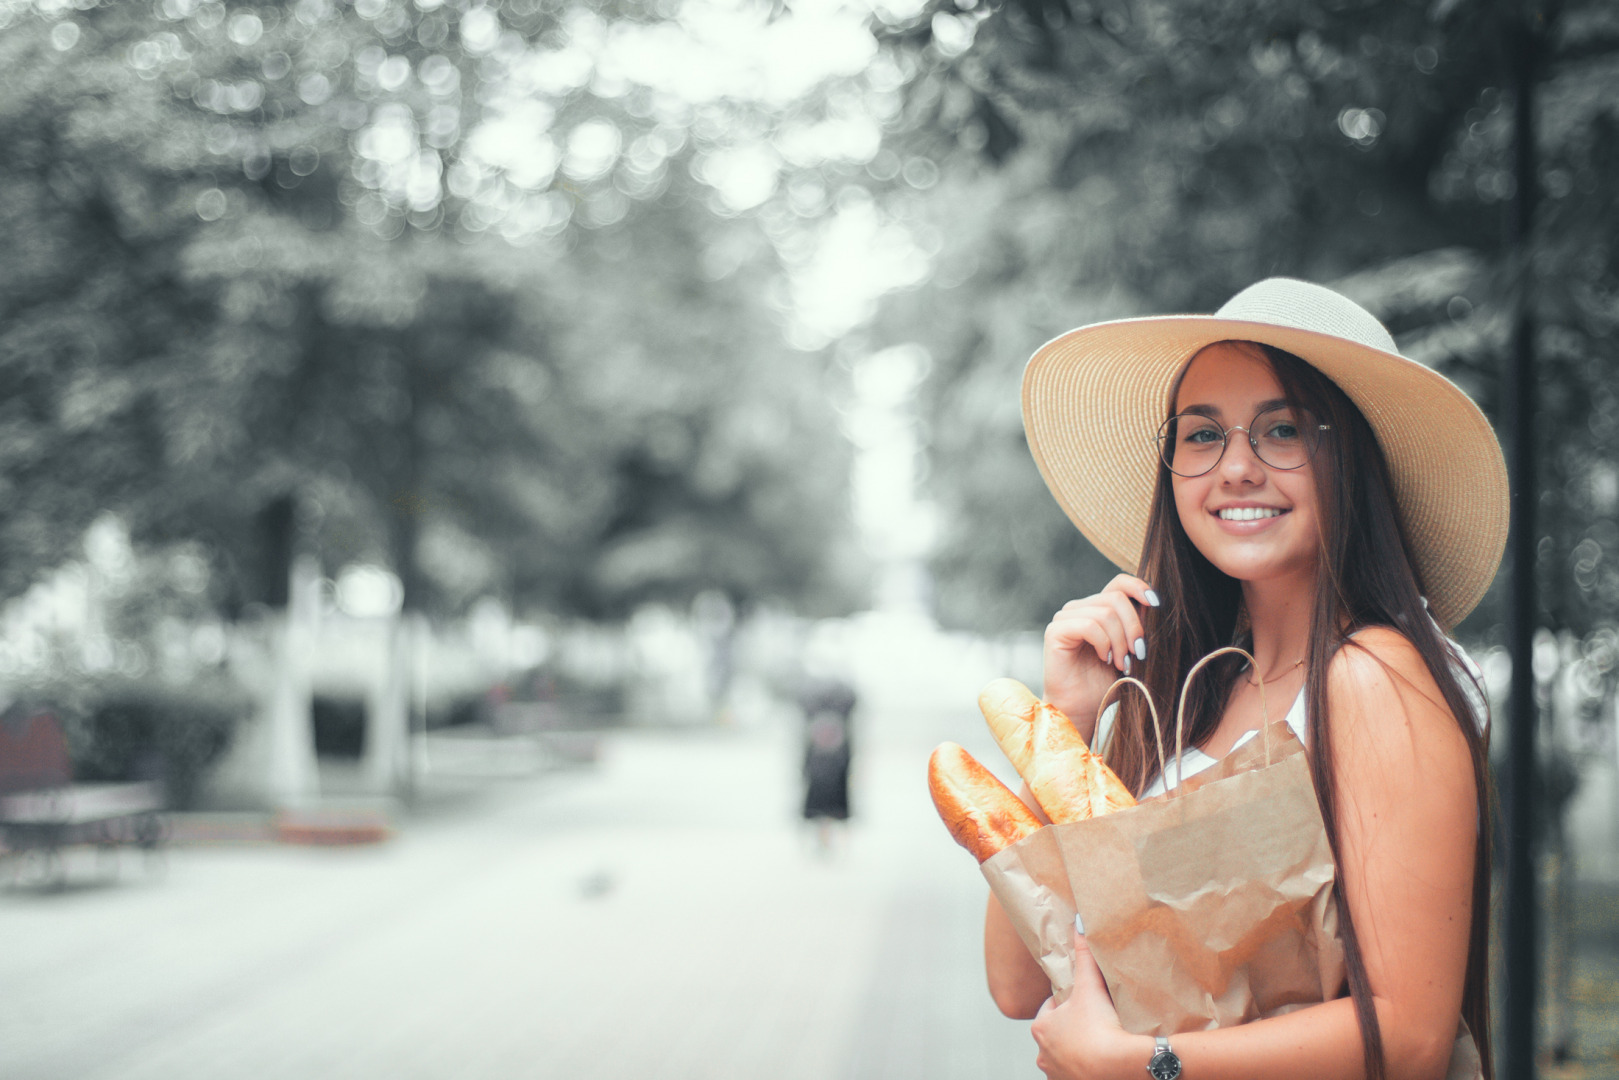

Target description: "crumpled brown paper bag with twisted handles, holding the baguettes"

left=981, top=648, right=1481, bottom=1080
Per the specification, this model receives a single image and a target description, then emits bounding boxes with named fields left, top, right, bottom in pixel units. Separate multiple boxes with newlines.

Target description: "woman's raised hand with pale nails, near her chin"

left=1044, top=573, right=1159, bottom=742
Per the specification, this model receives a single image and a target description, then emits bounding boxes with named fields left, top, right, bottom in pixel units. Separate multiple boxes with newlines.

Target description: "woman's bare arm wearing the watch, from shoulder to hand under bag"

left=1035, top=630, right=1478, bottom=1080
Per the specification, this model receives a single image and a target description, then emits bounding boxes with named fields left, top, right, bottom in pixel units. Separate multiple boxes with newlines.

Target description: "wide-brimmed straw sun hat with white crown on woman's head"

left=1023, top=277, right=1507, bottom=627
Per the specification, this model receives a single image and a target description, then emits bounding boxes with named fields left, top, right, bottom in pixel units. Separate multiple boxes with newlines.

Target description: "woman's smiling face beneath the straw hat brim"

left=1172, top=342, right=1319, bottom=581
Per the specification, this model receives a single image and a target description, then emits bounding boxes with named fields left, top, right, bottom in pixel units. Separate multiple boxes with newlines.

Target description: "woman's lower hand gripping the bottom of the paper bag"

left=1030, top=934, right=1153, bottom=1080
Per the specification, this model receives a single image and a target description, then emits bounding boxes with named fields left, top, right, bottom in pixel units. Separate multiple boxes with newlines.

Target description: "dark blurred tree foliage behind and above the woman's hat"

left=886, top=0, right=1619, bottom=635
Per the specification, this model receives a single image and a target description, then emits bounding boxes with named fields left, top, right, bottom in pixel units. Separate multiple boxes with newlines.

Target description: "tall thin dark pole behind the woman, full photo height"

left=1501, top=3, right=1540, bottom=1080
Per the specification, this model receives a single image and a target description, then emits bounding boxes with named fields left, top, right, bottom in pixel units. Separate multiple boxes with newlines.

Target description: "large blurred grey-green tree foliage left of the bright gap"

left=0, top=0, right=858, bottom=615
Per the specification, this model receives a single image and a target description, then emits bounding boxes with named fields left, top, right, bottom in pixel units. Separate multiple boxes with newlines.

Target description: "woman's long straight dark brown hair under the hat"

left=1107, top=342, right=1494, bottom=1080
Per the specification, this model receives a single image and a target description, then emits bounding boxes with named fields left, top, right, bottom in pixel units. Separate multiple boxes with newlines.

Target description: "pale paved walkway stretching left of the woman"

left=0, top=717, right=1039, bottom=1080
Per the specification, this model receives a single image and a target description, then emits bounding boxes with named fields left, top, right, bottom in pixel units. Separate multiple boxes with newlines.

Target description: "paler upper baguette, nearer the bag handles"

left=978, top=678, right=1135, bottom=824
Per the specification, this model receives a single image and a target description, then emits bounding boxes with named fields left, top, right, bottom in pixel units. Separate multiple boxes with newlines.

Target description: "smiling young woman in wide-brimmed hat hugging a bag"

left=984, top=279, right=1507, bottom=1080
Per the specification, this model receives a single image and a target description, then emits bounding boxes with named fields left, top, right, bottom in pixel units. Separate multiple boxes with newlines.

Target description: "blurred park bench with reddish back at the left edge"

left=0, top=706, right=167, bottom=884
